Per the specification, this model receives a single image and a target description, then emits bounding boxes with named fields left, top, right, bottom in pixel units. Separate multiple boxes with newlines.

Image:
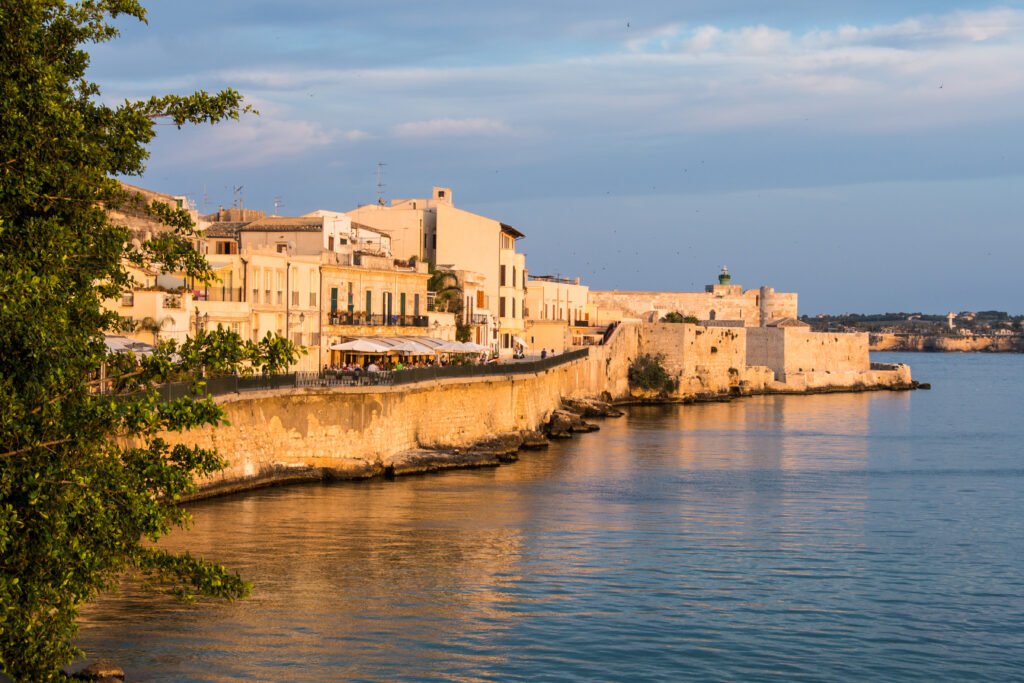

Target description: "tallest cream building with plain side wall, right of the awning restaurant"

left=348, top=187, right=527, bottom=355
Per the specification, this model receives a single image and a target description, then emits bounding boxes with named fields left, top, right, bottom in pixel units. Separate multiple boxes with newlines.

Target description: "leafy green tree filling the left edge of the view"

left=0, top=0, right=295, bottom=680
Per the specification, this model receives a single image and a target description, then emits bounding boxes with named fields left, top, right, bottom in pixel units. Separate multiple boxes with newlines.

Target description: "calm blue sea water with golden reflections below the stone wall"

left=80, top=354, right=1024, bottom=681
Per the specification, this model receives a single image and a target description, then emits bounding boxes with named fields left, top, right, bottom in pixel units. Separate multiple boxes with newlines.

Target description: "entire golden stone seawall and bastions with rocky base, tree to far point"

left=155, top=324, right=913, bottom=498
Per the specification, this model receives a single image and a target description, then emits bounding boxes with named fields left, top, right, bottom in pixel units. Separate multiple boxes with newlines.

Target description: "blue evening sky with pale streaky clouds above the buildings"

left=89, top=0, right=1024, bottom=315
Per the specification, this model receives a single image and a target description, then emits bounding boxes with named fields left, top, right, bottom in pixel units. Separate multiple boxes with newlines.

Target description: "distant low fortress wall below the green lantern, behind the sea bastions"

left=588, top=285, right=797, bottom=327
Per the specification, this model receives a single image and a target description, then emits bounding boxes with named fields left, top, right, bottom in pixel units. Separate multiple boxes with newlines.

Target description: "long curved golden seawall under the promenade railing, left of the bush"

left=162, top=326, right=637, bottom=493
